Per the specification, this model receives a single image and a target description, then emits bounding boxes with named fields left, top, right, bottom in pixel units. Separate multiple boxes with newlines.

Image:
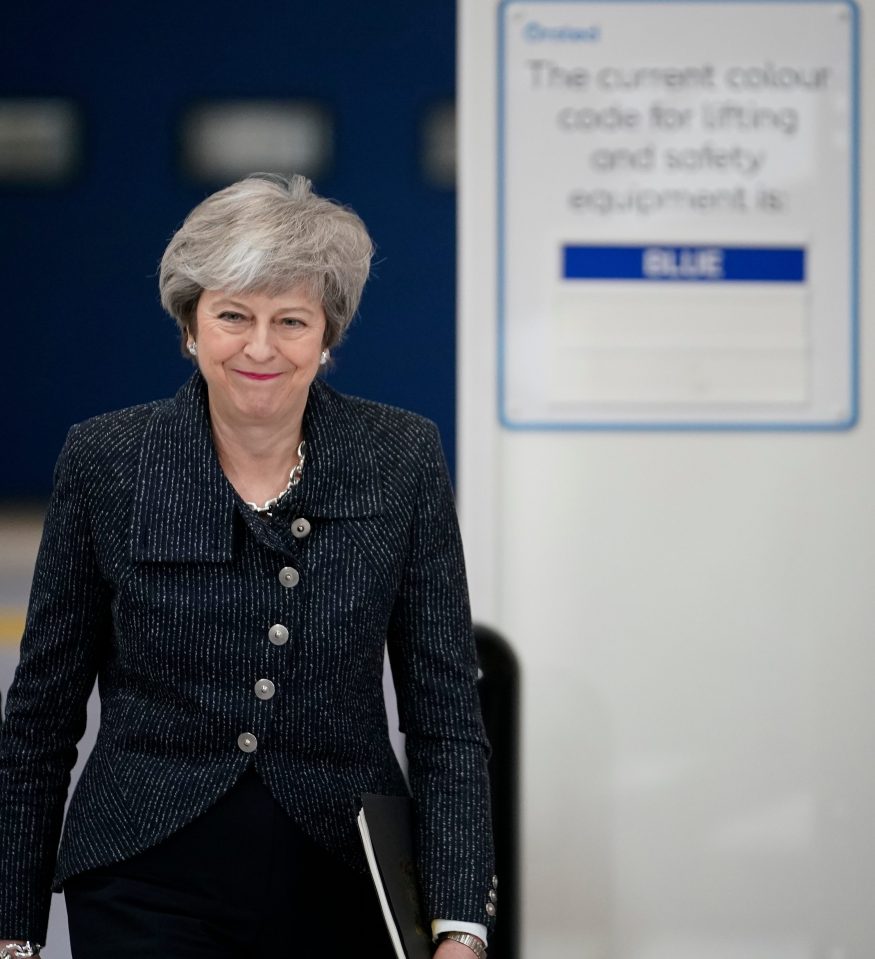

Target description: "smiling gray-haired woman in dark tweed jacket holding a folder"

left=0, top=175, right=497, bottom=959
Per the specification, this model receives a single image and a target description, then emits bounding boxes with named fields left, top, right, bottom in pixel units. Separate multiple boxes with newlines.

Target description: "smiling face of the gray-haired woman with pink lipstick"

left=193, top=287, right=325, bottom=426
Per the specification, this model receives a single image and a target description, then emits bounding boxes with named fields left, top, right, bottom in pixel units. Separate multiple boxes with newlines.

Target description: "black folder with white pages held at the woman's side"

left=358, top=794, right=433, bottom=959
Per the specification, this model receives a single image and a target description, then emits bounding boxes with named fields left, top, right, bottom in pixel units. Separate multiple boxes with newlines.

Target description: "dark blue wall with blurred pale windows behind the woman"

left=0, top=0, right=455, bottom=499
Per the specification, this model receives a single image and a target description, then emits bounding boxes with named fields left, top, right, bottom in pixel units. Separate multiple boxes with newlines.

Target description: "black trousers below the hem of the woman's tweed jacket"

left=64, top=770, right=394, bottom=959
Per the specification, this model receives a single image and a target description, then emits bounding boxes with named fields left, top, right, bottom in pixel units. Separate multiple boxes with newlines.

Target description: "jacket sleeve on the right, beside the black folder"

left=388, top=424, right=494, bottom=928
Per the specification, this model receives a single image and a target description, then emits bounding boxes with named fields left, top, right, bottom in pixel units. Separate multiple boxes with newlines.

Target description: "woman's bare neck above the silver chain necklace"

left=210, top=403, right=303, bottom=503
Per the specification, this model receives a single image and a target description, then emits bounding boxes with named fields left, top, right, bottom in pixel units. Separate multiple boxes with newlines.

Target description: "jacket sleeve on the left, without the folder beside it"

left=0, top=427, right=110, bottom=943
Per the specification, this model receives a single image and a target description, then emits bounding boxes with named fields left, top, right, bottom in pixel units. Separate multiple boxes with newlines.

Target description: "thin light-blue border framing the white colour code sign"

left=496, top=0, right=860, bottom=432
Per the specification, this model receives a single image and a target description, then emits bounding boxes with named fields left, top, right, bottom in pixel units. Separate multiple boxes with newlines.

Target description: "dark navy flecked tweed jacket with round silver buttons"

left=0, top=373, right=493, bottom=942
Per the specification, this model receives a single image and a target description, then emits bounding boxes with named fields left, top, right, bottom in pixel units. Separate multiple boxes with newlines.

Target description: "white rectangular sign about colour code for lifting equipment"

left=499, top=0, right=857, bottom=429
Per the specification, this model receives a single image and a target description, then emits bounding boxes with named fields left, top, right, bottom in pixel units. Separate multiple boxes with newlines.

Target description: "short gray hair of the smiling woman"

left=158, top=173, right=374, bottom=356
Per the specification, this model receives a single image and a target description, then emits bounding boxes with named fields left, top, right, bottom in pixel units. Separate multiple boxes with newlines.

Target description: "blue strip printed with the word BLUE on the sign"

left=562, top=245, right=805, bottom=283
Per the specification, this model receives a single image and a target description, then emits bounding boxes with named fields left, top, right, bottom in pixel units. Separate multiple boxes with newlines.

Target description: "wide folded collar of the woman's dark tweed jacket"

left=131, top=372, right=383, bottom=562
